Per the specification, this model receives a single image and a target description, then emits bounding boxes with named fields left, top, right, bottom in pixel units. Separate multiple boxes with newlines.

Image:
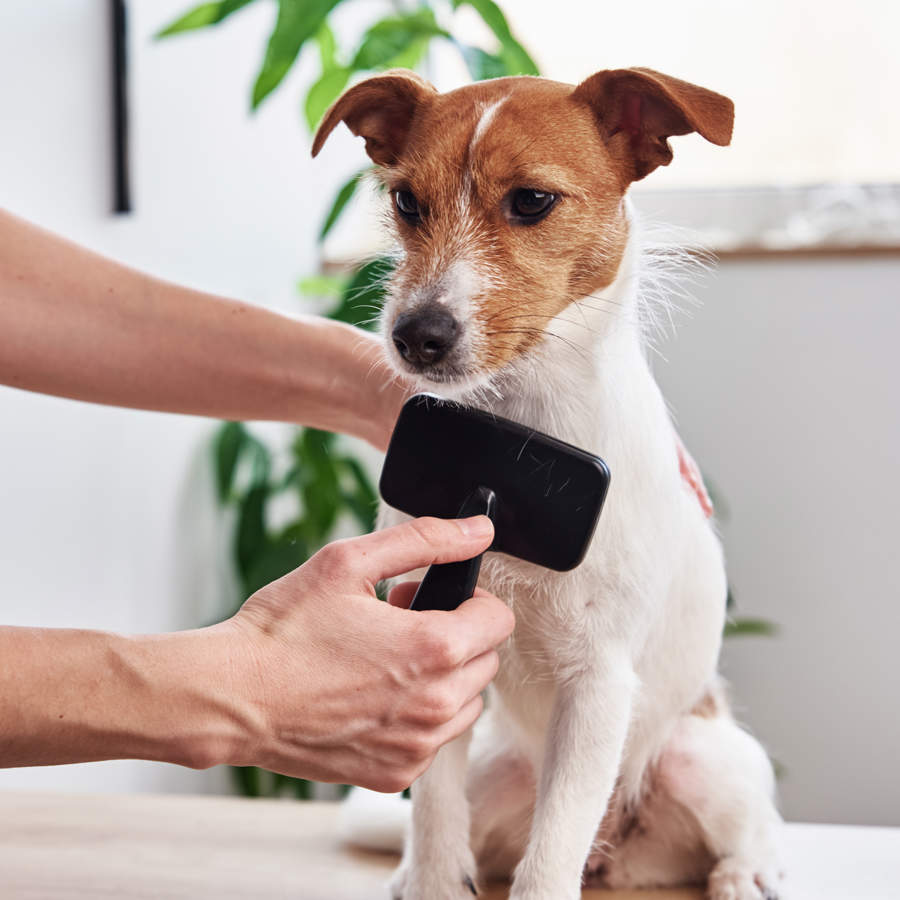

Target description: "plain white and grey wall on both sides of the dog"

left=0, top=0, right=900, bottom=824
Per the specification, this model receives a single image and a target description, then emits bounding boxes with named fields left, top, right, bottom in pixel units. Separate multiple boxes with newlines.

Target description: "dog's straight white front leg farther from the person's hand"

left=510, top=651, right=636, bottom=900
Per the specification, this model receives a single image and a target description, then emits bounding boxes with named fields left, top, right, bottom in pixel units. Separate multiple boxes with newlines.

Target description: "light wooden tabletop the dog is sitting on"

left=0, top=793, right=900, bottom=900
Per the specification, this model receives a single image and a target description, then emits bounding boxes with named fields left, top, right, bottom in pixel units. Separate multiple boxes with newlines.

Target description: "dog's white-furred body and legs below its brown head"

left=348, top=206, right=780, bottom=900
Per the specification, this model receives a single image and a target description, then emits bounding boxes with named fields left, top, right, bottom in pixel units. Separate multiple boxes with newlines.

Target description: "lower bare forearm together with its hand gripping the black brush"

left=0, top=517, right=513, bottom=791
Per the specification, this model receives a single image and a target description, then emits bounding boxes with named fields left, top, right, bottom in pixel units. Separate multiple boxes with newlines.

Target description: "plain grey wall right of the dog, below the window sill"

left=656, top=251, right=900, bottom=825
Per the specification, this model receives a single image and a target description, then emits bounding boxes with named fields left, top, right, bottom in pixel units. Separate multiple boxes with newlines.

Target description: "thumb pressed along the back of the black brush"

left=334, top=516, right=494, bottom=583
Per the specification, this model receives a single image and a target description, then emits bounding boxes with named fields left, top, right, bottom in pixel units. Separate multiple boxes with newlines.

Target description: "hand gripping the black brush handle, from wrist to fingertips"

left=217, top=516, right=514, bottom=791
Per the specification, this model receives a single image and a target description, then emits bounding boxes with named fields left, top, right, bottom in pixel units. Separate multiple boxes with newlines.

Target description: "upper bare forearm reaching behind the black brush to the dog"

left=0, top=211, right=403, bottom=447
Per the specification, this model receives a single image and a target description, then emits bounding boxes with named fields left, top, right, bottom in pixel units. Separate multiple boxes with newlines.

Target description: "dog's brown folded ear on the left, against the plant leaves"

left=312, top=69, right=437, bottom=166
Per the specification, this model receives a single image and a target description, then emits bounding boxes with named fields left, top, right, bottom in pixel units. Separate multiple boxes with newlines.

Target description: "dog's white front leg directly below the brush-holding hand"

left=391, top=728, right=477, bottom=900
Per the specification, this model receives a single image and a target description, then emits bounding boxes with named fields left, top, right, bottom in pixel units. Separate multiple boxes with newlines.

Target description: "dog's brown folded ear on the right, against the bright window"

left=572, top=68, right=734, bottom=183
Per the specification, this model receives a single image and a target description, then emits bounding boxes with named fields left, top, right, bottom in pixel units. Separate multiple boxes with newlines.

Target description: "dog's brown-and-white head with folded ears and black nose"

left=312, top=69, right=733, bottom=392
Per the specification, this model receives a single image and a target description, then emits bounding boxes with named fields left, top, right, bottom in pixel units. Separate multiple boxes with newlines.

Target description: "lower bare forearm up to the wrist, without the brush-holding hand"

left=0, top=626, right=253, bottom=768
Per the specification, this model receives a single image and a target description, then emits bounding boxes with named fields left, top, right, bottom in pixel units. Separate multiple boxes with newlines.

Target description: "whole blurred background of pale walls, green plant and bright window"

left=0, top=0, right=900, bottom=825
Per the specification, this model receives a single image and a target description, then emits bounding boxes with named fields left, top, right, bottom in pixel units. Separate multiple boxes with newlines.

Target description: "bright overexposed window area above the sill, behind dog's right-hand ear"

left=506, top=0, right=900, bottom=187
